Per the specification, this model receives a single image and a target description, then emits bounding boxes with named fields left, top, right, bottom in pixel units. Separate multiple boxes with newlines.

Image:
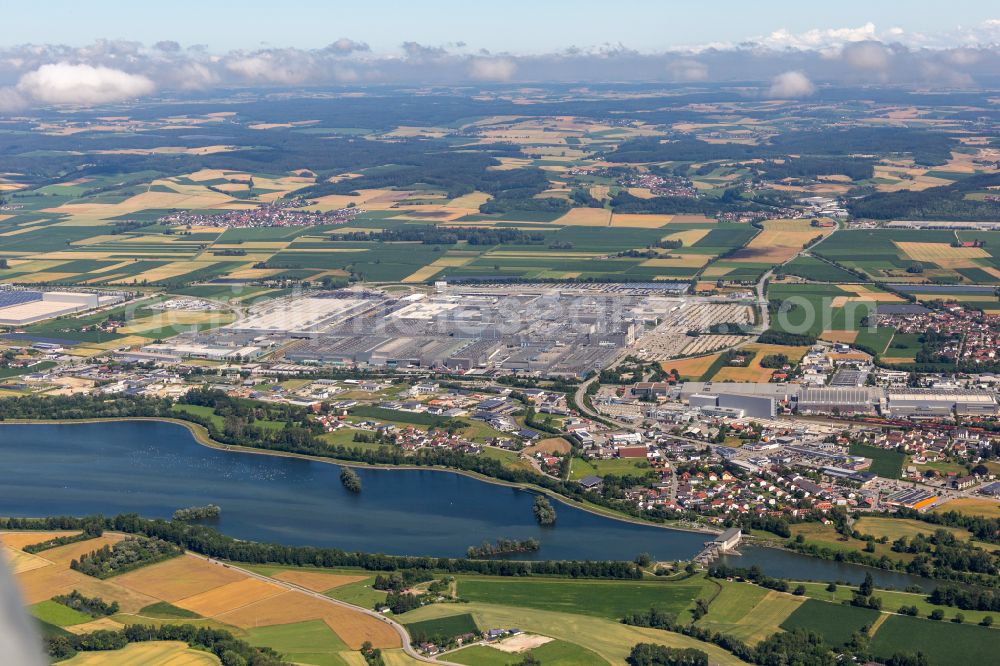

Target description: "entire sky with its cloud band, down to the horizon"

left=0, top=0, right=1000, bottom=109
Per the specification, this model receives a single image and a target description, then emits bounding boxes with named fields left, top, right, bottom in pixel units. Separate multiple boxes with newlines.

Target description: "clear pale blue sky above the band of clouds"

left=7, top=0, right=1000, bottom=54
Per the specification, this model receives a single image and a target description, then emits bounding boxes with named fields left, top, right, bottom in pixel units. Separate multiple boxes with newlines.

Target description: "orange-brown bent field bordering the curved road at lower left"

left=215, top=592, right=400, bottom=650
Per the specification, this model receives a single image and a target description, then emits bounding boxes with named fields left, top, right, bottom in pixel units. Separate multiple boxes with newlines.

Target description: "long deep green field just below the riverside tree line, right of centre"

left=458, top=577, right=708, bottom=620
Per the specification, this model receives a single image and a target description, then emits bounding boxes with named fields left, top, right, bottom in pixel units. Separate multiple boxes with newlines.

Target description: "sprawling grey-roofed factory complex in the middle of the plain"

left=143, top=284, right=745, bottom=378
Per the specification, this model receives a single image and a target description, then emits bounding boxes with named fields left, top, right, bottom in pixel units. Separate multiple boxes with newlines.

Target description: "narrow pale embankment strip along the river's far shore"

left=0, top=416, right=720, bottom=536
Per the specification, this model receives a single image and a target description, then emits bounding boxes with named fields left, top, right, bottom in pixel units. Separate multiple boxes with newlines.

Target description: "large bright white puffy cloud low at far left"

left=17, top=62, right=156, bottom=104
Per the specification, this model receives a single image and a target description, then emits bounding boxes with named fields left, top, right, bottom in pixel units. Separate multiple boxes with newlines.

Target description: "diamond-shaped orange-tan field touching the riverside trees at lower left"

left=115, top=555, right=244, bottom=603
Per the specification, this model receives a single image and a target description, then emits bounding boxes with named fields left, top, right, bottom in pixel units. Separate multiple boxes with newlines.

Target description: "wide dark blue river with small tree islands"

left=0, top=421, right=936, bottom=588
